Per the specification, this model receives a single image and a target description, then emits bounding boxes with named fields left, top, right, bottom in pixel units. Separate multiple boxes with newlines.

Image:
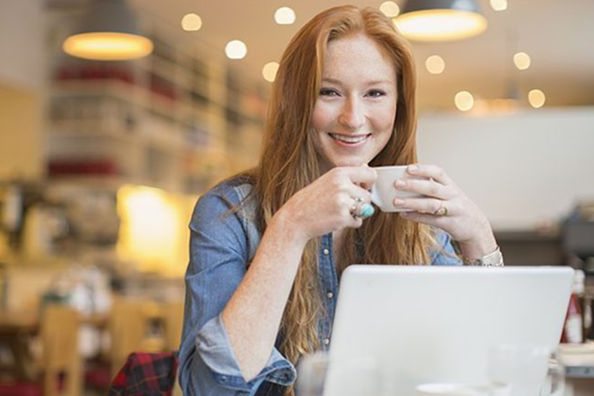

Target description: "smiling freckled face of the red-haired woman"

left=311, top=34, right=398, bottom=172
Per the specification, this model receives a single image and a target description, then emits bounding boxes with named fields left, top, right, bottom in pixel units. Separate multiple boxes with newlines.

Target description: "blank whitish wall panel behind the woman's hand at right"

left=418, top=107, right=594, bottom=230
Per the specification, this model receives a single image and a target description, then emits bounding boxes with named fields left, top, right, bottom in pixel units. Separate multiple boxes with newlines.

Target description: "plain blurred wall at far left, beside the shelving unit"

left=0, top=0, right=47, bottom=180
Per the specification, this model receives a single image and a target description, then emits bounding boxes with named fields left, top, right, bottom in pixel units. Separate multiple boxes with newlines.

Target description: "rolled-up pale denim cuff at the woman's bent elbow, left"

left=196, top=315, right=297, bottom=391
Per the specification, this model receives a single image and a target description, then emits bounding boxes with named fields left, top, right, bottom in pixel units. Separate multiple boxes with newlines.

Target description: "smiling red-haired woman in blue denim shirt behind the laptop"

left=179, top=6, right=500, bottom=395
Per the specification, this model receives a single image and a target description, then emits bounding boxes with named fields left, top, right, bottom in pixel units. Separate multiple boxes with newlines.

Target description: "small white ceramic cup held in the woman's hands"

left=371, top=165, right=419, bottom=212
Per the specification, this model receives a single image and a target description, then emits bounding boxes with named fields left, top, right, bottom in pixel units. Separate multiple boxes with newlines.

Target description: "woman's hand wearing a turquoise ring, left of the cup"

left=275, top=166, right=377, bottom=242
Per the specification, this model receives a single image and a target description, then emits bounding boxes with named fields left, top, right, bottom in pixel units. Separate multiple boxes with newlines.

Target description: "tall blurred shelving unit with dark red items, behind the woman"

left=46, top=13, right=266, bottom=194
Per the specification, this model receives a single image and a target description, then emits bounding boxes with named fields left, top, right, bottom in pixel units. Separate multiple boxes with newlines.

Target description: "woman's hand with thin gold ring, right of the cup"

left=394, top=164, right=497, bottom=257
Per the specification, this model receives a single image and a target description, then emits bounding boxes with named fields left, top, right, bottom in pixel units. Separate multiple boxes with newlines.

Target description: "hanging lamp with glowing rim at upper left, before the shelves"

left=62, top=0, right=153, bottom=60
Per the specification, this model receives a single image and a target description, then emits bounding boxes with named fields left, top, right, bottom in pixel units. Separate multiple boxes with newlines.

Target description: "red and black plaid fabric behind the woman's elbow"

left=109, top=352, right=177, bottom=396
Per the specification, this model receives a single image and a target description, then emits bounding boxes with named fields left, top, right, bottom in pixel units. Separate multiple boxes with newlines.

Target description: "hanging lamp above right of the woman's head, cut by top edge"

left=394, top=0, right=487, bottom=41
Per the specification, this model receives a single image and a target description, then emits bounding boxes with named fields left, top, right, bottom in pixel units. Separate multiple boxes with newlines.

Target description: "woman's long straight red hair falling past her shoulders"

left=243, top=6, right=433, bottom=393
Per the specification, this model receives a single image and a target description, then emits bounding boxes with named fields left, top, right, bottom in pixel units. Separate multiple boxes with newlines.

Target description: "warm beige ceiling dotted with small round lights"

left=128, top=0, right=594, bottom=110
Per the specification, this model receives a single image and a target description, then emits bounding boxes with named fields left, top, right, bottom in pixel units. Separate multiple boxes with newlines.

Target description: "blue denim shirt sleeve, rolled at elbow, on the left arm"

left=179, top=180, right=296, bottom=396
